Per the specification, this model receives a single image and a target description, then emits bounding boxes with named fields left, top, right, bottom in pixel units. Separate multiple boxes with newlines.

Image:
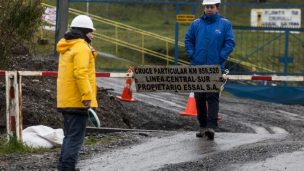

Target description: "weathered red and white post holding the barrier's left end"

left=5, top=71, right=22, bottom=140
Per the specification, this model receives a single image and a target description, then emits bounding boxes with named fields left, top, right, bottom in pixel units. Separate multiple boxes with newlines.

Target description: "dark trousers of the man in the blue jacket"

left=194, top=93, right=219, bottom=128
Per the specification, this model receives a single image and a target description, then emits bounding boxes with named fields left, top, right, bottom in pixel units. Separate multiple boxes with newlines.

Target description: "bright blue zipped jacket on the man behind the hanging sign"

left=185, top=13, right=235, bottom=71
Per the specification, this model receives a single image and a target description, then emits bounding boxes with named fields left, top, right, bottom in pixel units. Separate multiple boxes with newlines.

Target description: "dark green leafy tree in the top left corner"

left=0, top=0, right=43, bottom=69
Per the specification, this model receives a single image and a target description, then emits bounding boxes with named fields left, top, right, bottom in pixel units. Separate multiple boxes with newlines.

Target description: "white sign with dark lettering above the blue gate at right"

left=251, top=9, right=301, bottom=28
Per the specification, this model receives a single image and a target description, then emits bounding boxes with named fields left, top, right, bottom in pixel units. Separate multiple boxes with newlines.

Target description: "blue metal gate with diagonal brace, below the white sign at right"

left=232, top=26, right=304, bottom=75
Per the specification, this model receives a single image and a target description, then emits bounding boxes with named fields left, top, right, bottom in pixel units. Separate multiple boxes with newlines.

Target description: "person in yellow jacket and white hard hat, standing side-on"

left=57, top=15, right=97, bottom=171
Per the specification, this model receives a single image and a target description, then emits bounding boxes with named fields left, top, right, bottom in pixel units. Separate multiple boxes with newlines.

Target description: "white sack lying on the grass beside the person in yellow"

left=22, top=125, right=64, bottom=148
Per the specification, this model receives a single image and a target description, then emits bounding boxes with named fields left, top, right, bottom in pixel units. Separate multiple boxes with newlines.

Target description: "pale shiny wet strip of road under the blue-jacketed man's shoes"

left=78, top=132, right=286, bottom=171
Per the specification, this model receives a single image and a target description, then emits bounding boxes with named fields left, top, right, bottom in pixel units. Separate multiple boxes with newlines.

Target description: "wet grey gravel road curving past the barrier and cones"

left=79, top=79, right=304, bottom=171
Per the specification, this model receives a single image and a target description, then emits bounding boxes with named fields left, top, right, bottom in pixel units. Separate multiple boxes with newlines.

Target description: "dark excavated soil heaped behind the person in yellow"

left=0, top=56, right=195, bottom=130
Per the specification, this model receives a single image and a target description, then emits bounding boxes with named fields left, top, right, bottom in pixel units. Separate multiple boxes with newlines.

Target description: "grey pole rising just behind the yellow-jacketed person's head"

left=54, top=0, right=69, bottom=56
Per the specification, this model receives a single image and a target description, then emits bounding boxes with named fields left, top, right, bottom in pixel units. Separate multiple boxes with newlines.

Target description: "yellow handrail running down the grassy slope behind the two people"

left=42, top=3, right=288, bottom=73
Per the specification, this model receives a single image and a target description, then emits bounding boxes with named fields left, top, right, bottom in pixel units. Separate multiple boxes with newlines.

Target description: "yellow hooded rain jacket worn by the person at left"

left=57, top=39, right=97, bottom=108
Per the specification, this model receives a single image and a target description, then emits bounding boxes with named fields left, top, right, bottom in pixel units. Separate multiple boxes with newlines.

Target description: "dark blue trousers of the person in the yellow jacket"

left=58, top=112, right=88, bottom=171
